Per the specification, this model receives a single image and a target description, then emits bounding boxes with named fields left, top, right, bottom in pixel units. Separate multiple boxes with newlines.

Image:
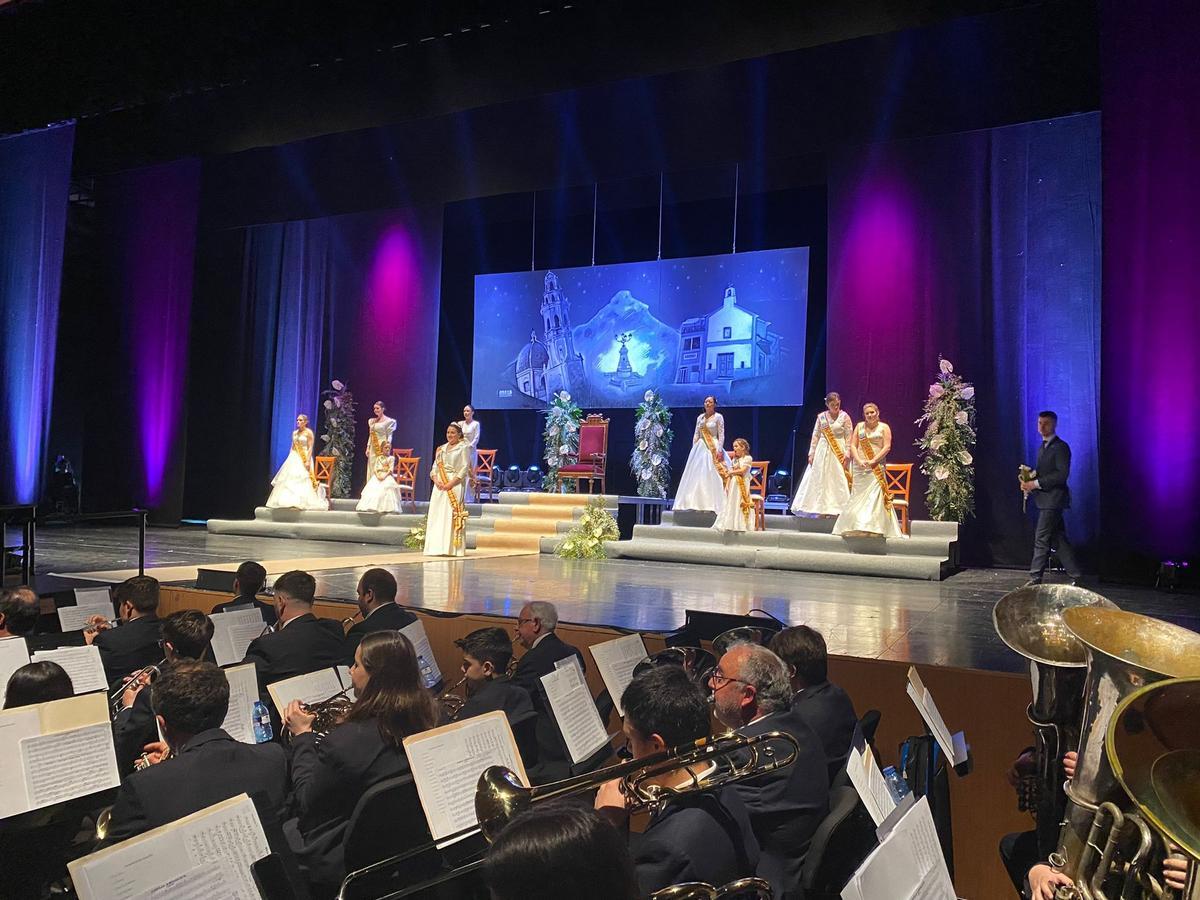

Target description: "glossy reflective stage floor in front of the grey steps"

left=37, top=527, right=1200, bottom=672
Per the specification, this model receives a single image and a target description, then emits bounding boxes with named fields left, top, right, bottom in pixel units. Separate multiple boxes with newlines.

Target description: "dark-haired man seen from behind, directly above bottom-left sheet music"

left=107, top=660, right=288, bottom=842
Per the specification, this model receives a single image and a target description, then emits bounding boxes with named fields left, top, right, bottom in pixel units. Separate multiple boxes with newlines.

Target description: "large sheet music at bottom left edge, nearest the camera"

left=68, top=794, right=271, bottom=900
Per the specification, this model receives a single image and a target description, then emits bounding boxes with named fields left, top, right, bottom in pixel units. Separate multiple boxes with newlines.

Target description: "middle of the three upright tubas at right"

left=1050, top=606, right=1200, bottom=900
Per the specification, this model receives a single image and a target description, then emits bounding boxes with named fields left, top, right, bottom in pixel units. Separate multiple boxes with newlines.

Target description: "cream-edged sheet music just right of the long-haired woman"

left=404, top=710, right=529, bottom=846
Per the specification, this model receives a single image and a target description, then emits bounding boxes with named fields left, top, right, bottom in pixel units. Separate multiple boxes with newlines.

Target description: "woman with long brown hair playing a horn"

left=284, top=631, right=438, bottom=886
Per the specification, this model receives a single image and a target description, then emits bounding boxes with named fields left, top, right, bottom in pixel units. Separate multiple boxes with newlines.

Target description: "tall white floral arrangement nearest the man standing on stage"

left=917, top=358, right=976, bottom=522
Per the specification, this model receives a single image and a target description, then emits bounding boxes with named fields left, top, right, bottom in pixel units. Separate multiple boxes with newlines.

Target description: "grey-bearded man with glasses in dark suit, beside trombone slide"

left=708, top=643, right=829, bottom=900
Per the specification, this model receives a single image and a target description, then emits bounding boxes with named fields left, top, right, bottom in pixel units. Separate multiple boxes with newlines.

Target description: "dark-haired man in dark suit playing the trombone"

left=595, top=666, right=758, bottom=896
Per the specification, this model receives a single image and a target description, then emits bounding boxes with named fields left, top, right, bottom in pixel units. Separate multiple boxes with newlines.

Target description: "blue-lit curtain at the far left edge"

left=0, top=125, right=74, bottom=503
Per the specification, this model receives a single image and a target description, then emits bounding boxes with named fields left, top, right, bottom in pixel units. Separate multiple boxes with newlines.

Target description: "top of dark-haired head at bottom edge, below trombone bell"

left=484, top=800, right=643, bottom=900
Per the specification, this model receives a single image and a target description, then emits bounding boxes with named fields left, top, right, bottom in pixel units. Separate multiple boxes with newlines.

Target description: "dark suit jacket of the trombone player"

left=629, top=787, right=758, bottom=896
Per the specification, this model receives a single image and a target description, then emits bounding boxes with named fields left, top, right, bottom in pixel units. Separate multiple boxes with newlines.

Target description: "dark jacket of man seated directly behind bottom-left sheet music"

left=108, top=728, right=288, bottom=844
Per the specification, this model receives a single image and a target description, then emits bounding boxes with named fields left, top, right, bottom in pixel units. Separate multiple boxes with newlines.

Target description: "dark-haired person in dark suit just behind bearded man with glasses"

left=768, top=625, right=858, bottom=781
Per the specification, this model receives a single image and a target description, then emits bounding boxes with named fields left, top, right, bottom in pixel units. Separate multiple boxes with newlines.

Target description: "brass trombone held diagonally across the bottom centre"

left=337, top=731, right=799, bottom=900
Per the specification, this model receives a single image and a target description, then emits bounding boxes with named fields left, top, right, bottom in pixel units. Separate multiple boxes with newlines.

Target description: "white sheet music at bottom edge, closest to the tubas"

left=841, top=797, right=955, bottom=900
